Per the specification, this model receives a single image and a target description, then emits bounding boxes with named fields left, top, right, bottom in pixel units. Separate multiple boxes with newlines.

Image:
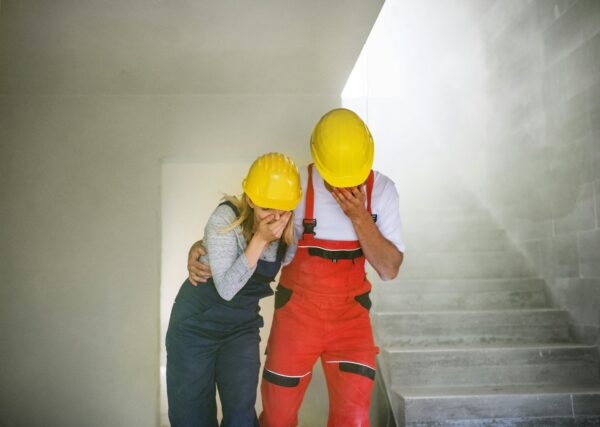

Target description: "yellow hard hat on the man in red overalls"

left=310, top=108, right=374, bottom=187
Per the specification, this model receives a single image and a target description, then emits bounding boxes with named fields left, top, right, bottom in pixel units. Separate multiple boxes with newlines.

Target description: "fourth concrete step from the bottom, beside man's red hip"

left=372, top=279, right=548, bottom=312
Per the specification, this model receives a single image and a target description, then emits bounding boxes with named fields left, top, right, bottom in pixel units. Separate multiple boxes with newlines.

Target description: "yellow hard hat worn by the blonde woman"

left=242, top=153, right=302, bottom=211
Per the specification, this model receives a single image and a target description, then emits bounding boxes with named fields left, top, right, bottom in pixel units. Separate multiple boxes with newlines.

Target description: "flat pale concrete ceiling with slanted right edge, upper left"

left=0, top=0, right=383, bottom=95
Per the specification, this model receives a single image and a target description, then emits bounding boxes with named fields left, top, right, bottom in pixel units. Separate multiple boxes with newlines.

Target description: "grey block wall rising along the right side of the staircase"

left=479, top=0, right=600, bottom=342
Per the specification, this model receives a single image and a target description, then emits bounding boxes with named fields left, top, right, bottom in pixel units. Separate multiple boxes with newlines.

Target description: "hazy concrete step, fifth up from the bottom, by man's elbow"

left=400, top=251, right=534, bottom=279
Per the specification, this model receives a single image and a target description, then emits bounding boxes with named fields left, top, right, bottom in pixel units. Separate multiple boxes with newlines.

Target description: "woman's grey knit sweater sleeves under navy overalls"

left=200, top=205, right=296, bottom=301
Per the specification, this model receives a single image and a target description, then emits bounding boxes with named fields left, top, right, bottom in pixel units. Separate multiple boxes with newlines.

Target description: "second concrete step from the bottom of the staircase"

left=382, top=344, right=600, bottom=387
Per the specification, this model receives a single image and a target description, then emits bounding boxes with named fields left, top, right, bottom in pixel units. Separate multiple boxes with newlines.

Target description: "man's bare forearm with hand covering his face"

left=331, top=186, right=404, bottom=280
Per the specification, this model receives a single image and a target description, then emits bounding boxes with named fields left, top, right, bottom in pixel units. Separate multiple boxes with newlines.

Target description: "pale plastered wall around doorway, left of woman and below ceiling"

left=0, top=96, right=332, bottom=426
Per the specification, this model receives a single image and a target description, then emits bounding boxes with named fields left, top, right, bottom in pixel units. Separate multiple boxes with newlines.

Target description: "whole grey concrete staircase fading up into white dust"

left=370, top=197, right=600, bottom=427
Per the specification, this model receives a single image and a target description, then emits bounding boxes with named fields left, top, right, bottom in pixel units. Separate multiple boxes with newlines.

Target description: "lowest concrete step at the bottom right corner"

left=391, top=386, right=600, bottom=427
